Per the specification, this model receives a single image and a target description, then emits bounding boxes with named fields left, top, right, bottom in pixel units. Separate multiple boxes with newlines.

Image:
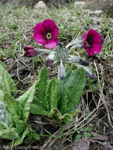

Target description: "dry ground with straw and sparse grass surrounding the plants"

left=0, top=1, right=113, bottom=150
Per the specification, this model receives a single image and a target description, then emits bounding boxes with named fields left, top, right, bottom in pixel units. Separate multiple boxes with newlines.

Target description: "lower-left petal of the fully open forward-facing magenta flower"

left=33, top=32, right=46, bottom=44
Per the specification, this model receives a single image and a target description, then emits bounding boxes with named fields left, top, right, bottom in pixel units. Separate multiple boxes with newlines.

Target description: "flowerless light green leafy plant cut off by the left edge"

left=0, top=62, right=36, bottom=146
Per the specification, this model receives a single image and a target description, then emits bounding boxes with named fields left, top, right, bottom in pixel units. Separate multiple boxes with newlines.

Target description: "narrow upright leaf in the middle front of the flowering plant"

left=46, top=78, right=60, bottom=110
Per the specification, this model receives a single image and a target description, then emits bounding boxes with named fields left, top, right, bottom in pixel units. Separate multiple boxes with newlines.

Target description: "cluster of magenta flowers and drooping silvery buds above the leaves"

left=24, top=19, right=101, bottom=80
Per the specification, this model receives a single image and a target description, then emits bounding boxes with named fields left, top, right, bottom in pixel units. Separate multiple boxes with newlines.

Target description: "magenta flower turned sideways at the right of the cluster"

left=83, top=29, right=101, bottom=56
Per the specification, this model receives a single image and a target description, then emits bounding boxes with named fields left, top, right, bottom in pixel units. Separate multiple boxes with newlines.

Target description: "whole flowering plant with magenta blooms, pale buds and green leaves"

left=24, top=19, right=101, bottom=123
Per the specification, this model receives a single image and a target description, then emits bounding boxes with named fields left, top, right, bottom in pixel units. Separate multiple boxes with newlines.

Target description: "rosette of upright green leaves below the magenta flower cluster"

left=30, top=67, right=86, bottom=123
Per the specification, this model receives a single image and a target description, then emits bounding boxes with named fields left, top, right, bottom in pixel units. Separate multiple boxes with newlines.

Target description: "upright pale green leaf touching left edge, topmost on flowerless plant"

left=0, top=62, right=16, bottom=95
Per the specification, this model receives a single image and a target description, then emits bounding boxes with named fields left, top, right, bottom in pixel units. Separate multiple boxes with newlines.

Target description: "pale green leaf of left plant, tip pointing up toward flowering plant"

left=16, top=82, right=37, bottom=121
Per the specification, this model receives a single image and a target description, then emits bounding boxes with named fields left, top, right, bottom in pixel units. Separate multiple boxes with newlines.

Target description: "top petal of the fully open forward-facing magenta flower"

left=42, top=19, right=56, bottom=32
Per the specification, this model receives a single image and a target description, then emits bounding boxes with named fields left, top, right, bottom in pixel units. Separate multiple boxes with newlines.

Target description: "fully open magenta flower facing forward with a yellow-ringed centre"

left=33, top=19, right=59, bottom=48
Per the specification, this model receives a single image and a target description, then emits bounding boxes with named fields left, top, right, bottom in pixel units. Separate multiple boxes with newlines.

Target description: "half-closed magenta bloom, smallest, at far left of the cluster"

left=24, top=47, right=38, bottom=57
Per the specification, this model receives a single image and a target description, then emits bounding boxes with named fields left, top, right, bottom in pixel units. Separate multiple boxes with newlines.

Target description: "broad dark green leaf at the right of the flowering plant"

left=65, top=68, right=86, bottom=111
